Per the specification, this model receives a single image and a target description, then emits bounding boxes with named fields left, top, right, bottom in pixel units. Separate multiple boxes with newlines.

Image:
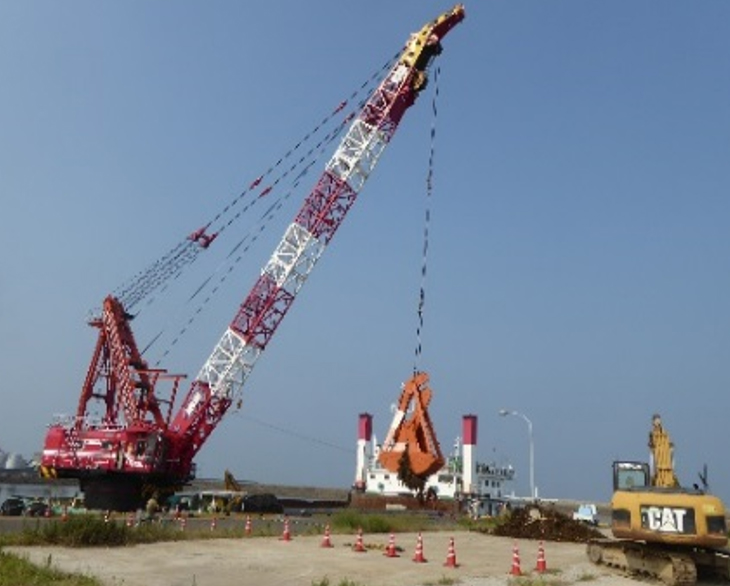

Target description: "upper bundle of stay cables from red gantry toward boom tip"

left=111, top=54, right=398, bottom=313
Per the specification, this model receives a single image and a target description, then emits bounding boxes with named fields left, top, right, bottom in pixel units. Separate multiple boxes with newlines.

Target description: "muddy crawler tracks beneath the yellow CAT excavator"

left=586, top=539, right=730, bottom=586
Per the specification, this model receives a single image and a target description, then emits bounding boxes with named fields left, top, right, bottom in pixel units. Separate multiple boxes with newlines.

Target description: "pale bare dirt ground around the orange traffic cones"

left=9, top=532, right=646, bottom=586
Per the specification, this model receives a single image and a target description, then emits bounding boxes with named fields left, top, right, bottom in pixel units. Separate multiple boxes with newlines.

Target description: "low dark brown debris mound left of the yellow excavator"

left=493, top=506, right=604, bottom=543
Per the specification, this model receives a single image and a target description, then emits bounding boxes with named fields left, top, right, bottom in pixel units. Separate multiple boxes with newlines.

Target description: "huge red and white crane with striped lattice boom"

left=41, top=5, right=464, bottom=510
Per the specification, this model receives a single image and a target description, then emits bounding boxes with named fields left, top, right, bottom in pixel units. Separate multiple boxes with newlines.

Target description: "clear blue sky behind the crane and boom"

left=0, top=0, right=730, bottom=500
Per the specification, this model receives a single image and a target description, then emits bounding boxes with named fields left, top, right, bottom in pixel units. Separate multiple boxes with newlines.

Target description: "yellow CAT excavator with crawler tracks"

left=587, top=415, right=730, bottom=586
